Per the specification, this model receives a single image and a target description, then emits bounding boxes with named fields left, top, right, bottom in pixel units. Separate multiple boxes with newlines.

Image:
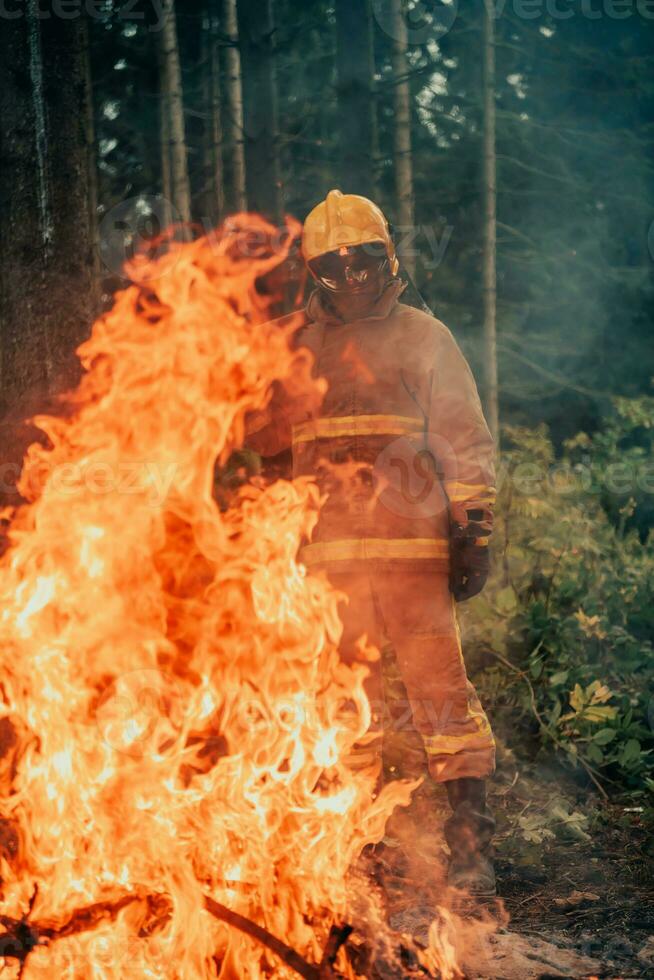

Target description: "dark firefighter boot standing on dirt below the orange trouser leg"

left=445, top=779, right=495, bottom=898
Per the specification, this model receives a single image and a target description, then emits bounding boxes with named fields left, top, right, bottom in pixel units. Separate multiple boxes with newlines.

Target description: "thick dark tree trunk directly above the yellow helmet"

left=336, top=0, right=376, bottom=198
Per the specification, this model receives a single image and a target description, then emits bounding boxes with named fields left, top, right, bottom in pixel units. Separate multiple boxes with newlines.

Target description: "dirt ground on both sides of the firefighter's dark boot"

left=368, top=750, right=654, bottom=980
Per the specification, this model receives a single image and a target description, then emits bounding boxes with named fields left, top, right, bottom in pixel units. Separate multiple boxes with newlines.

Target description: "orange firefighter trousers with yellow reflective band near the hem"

left=328, top=568, right=495, bottom=782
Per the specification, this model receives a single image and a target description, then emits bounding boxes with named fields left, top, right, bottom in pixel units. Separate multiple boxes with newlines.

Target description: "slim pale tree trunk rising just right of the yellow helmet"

left=391, top=0, right=416, bottom=279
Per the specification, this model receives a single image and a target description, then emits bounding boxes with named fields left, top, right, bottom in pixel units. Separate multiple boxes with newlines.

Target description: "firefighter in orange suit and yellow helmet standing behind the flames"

left=249, top=190, right=495, bottom=896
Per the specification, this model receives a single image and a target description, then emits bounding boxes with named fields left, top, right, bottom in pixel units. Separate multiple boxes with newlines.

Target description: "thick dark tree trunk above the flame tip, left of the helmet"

left=237, top=0, right=284, bottom=222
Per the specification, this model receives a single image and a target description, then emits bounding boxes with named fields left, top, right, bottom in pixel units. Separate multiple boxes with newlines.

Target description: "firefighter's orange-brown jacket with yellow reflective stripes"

left=248, top=279, right=495, bottom=572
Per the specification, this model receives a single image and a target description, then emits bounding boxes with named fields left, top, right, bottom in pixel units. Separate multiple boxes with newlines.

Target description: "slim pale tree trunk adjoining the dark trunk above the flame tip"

left=220, top=0, right=247, bottom=211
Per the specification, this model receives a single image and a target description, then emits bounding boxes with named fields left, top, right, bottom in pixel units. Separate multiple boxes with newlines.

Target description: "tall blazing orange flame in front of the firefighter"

left=0, top=216, right=462, bottom=980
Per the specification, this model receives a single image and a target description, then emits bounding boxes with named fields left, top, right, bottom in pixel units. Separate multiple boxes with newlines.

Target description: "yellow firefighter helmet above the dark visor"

left=302, top=191, right=399, bottom=276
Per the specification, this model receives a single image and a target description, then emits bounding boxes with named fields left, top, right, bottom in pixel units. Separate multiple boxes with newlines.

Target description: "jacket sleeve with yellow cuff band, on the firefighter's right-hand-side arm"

left=428, top=323, right=496, bottom=533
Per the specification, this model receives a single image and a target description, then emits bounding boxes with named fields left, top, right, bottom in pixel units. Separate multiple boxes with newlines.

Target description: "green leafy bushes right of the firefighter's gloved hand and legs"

left=464, top=399, right=654, bottom=794
